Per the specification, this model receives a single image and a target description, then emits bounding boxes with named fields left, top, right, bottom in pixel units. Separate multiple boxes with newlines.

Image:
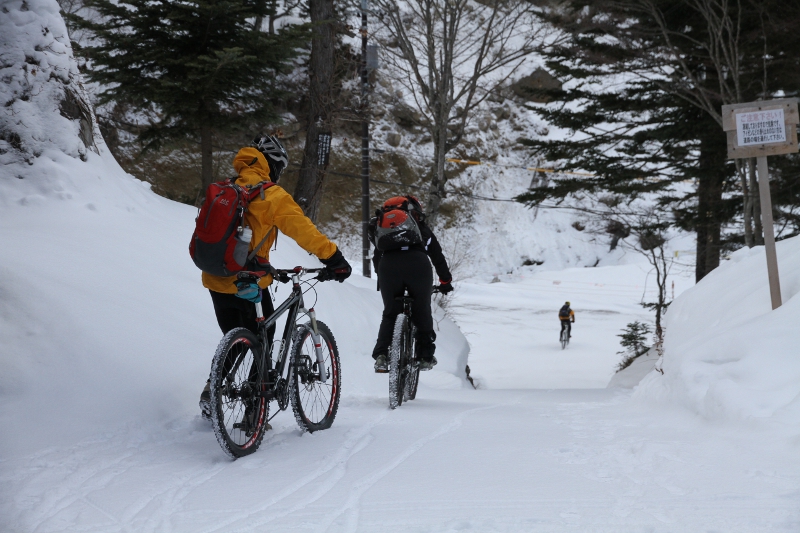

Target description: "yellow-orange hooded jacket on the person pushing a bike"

left=203, top=147, right=336, bottom=294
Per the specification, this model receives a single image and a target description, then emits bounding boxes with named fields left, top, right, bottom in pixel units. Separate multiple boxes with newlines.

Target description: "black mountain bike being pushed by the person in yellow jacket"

left=209, top=267, right=341, bottom=459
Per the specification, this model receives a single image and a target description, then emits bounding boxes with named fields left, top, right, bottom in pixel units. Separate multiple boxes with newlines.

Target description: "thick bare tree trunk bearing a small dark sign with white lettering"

left=294, top=0, right=336, bottom=222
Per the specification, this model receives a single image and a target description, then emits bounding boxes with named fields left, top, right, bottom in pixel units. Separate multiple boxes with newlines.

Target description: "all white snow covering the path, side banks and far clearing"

left=0, top=0, right=800, bottom=533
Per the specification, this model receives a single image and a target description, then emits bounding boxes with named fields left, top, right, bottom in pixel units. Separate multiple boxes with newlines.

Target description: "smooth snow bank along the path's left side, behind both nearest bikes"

left=0, top=150, right=468, bottom=458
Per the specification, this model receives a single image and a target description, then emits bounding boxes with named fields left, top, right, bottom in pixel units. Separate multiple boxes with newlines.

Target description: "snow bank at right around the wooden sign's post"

left=635, top=237, right=800, bottom=421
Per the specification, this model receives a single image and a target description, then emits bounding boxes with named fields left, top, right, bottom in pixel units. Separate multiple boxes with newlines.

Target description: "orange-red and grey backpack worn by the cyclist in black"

left=375, top=196, right=425, bottom=252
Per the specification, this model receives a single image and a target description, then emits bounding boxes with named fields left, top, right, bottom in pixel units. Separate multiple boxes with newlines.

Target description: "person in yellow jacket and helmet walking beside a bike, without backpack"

left=200, top=135, right=352, bottom=415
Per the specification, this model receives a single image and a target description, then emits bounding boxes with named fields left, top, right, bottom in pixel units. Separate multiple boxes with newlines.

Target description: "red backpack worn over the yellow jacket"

left=189, top=177, right=275, bottom=276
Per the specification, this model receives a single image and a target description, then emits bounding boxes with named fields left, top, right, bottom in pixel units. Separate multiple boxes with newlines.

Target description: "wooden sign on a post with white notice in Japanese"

left=722, top=98, right=800, bottom=309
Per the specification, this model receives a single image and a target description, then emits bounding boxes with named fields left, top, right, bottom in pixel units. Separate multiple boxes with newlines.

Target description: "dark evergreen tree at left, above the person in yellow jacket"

left=69, top=0, right=306, bottom=188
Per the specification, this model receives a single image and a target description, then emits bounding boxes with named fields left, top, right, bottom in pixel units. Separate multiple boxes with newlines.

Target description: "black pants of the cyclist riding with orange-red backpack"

left=372, top=250, right=436, bottom=359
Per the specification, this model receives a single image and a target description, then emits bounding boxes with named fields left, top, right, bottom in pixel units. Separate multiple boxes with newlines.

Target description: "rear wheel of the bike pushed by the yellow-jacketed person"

left=209, top=328, right=269, bottom=459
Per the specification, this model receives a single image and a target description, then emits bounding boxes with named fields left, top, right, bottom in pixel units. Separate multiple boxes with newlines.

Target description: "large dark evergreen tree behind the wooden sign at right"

left=519, top=0, right=800, bottom=280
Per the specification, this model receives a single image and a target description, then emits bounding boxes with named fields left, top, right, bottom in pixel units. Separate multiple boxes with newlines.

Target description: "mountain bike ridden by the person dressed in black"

left=389, top=287, right=439, bottom=409
